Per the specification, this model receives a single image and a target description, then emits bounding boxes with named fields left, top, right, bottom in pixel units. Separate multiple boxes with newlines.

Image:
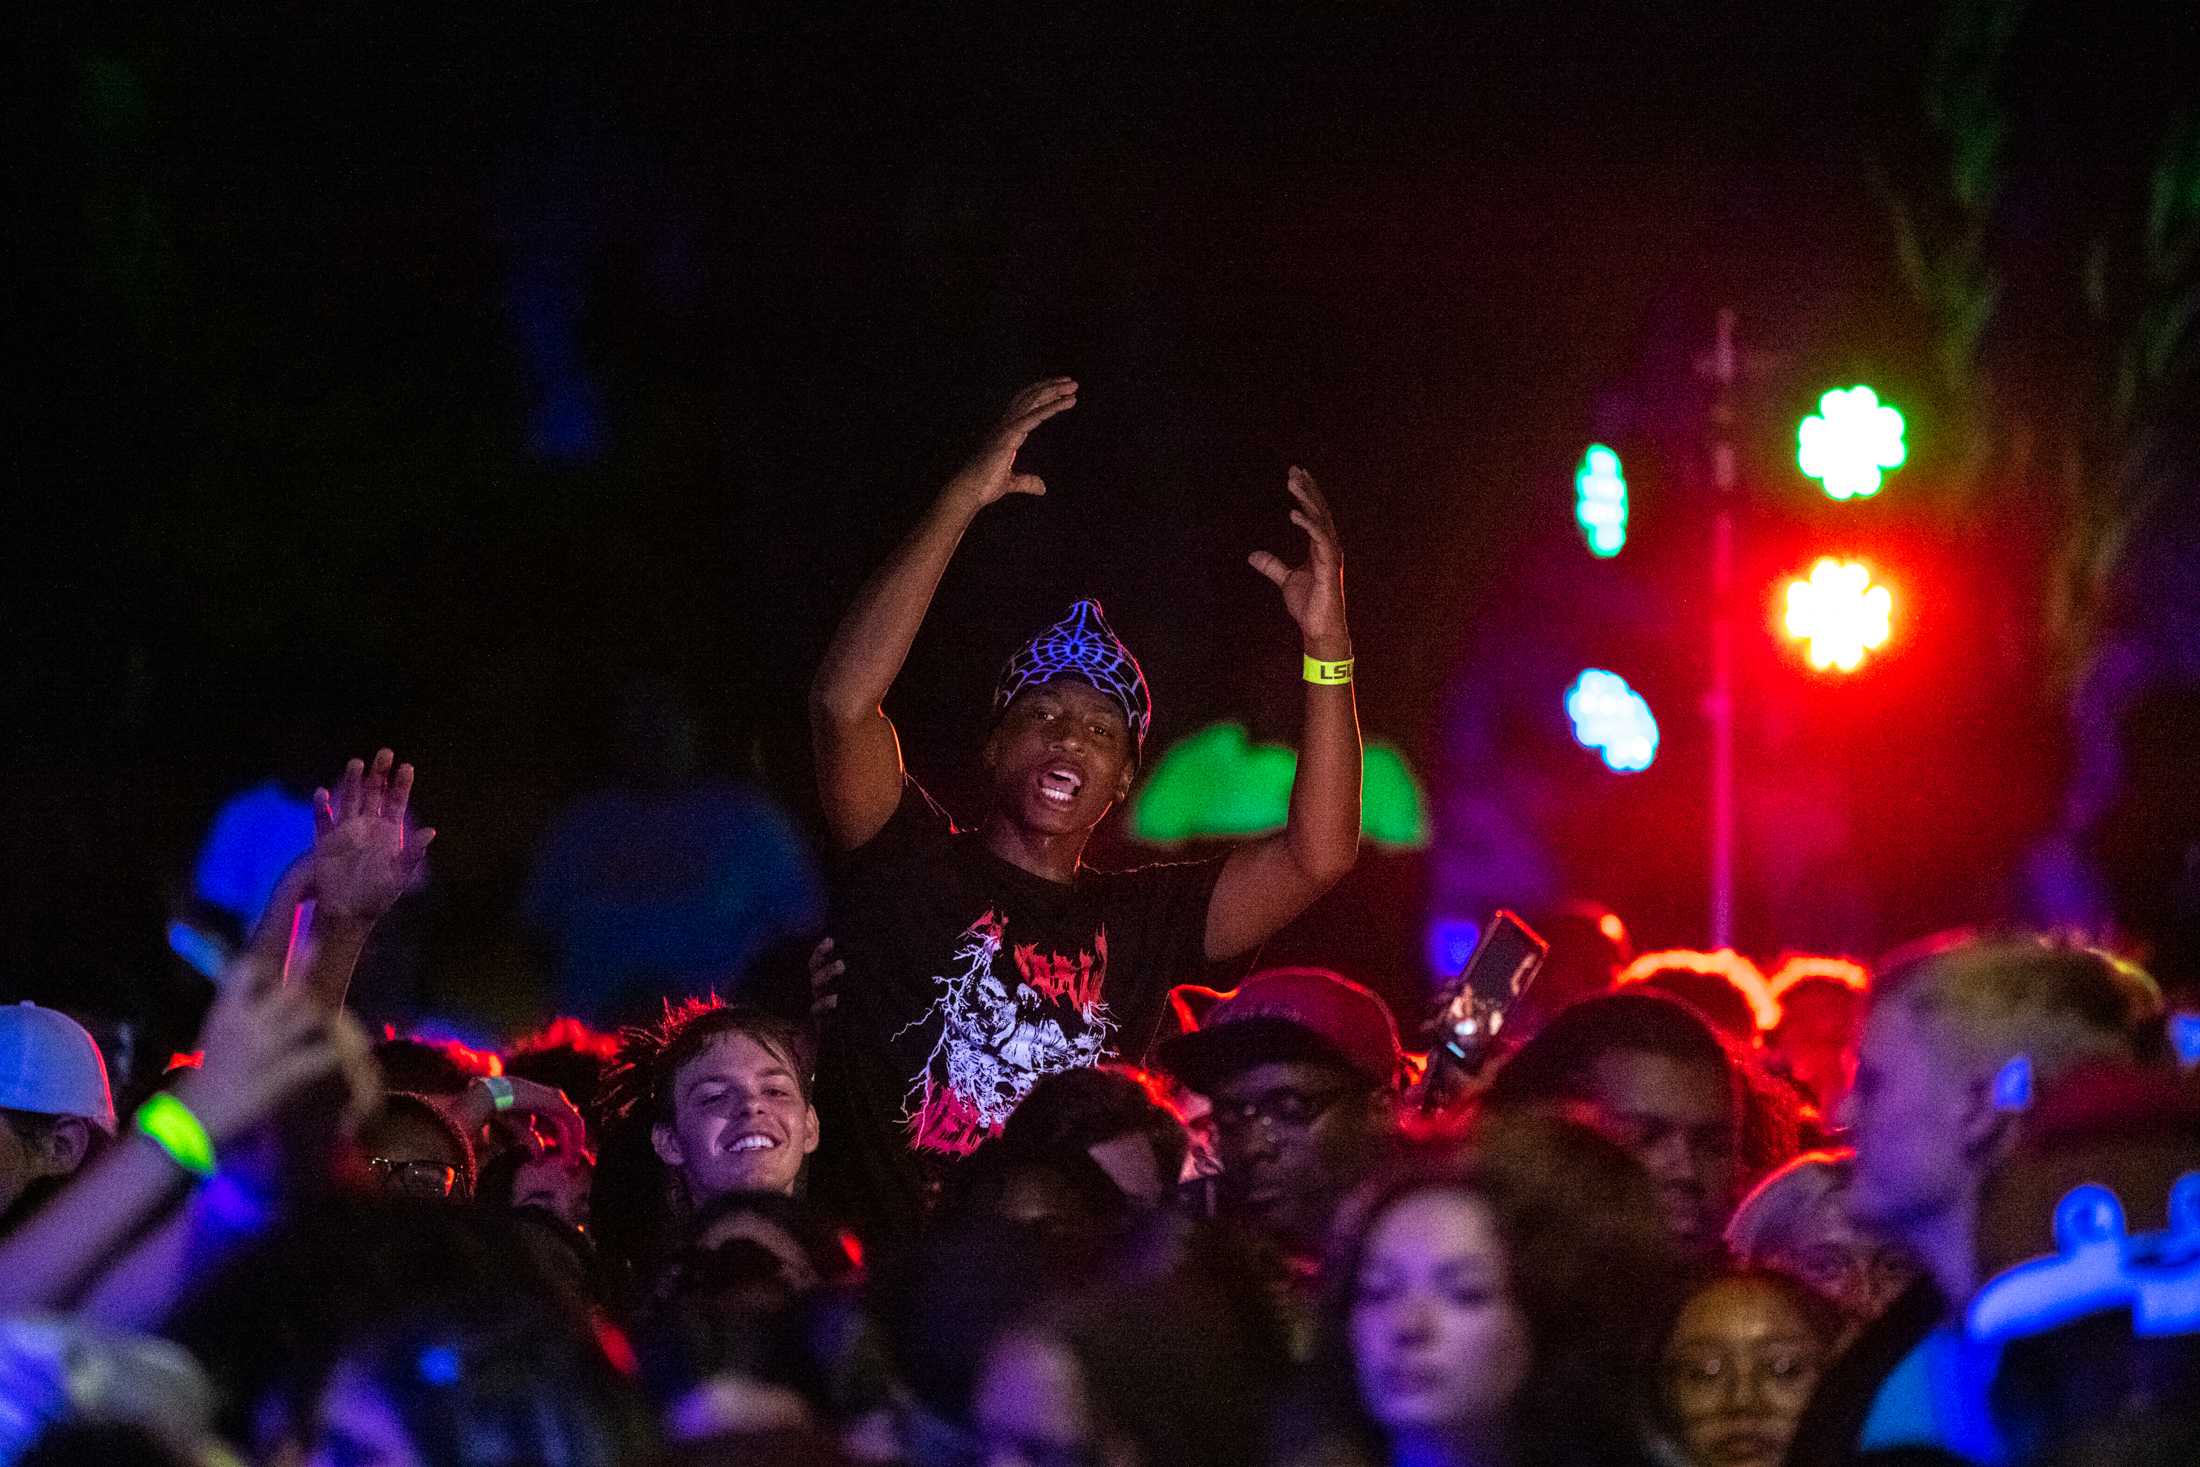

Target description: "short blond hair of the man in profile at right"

left=1872, top=935, right=2163, bottom=1080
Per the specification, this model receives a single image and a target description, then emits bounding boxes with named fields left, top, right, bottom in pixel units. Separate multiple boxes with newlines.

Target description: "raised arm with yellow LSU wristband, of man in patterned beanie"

left=1206, top=468, right=1360, bottom=959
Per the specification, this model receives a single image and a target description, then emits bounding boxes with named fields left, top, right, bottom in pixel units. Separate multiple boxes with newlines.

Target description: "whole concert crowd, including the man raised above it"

left=0, top=380, right=2200, bottom=1467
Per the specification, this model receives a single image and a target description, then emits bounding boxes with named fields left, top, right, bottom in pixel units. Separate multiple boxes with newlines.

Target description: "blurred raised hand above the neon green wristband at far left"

left=176, top=952, right=365, bottom=1148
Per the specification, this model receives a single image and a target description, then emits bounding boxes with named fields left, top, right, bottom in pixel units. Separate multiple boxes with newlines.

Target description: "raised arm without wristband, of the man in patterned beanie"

left=810, top=376, right=1078, bottom=851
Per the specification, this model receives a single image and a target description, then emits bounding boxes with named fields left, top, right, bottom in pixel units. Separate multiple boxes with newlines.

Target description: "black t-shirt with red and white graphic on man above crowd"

left=812, top=779, right=1221, bottom=1234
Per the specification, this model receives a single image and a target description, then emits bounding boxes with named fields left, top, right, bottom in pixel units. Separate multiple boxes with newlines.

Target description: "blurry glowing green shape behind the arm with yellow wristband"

left=1131, top=724, right=1428, bottom=849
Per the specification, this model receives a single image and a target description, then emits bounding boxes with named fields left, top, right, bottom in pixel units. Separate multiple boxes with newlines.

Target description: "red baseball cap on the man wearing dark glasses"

left=1155, top=968, right=1406, bottom=1095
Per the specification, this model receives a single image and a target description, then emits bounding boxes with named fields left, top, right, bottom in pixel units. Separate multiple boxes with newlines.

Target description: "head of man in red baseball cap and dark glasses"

left=1157, top=968, right=1406, bottom=1273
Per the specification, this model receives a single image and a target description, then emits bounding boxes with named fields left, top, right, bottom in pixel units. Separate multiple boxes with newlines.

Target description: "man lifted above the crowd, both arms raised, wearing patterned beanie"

left=810, top=378, right=1360, bottom=1234
